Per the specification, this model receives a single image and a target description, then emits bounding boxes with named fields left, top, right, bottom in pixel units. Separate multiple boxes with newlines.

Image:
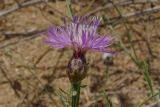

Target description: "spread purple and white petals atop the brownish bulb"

left=46, top=16, right=112, bottom=56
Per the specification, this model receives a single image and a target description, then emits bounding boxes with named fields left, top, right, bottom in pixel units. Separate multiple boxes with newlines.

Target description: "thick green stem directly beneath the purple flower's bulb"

left=72, top=82, right=81, bottom=107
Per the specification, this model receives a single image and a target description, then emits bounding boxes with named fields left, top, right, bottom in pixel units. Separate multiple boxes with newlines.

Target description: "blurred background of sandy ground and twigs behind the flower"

left=0, top=0, right=160, bottom=107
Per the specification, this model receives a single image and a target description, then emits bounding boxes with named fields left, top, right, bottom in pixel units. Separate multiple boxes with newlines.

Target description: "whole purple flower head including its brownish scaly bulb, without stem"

left=46, top=16, right=112, bottom=81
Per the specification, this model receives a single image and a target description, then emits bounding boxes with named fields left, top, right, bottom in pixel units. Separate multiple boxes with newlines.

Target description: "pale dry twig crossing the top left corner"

left=0, top=0, right=44, bottom=17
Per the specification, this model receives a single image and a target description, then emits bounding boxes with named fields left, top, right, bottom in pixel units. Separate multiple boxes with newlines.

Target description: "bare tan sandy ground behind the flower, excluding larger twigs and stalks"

left=0, top=0, right=160, bottom=107
